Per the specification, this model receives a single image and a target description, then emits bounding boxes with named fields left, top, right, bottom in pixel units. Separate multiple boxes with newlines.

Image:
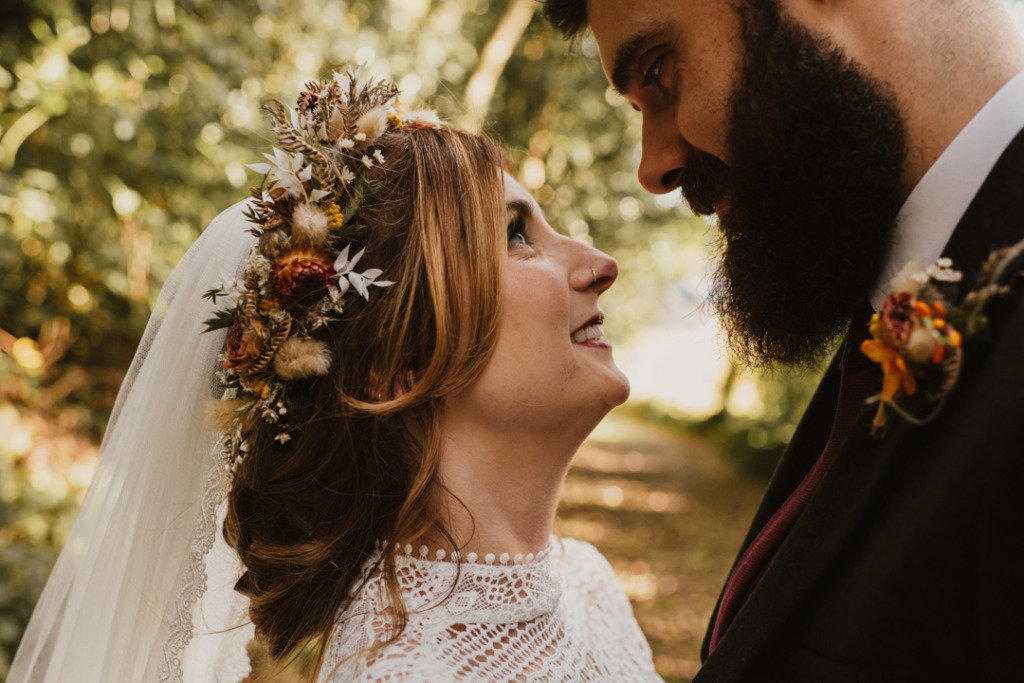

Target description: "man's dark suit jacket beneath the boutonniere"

left=694, top=132, right=1024, bottom=683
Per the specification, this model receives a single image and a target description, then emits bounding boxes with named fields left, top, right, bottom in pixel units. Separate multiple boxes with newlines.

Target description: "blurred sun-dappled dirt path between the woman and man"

left=556, top=414, right=762, bottom=681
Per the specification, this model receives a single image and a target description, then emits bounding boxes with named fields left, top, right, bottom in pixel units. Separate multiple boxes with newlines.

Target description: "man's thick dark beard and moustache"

left=681, top=0, right=906, bottom=367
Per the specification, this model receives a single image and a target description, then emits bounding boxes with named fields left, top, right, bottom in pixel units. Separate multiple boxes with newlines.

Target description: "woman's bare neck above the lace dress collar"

left=437, top=421, right=590, bottom=557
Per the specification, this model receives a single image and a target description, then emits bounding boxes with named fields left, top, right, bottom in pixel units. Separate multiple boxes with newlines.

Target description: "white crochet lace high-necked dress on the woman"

left=318, top=537, right=662, bottom=683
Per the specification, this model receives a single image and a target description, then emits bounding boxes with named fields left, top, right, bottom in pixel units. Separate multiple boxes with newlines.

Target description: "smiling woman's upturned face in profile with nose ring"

left=449, top=174, right=630, bottom=432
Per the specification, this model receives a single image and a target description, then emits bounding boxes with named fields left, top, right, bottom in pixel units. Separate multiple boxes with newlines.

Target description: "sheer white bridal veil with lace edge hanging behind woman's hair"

left=8, top=203, right=255, bottom=683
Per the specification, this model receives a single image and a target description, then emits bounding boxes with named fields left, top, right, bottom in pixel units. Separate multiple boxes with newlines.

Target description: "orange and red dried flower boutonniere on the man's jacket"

left=860, top=242, right=1024, bottom=438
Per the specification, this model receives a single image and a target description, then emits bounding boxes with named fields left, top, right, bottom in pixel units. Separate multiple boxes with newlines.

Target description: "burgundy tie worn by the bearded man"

left=711, top=315, right=882, bottom=650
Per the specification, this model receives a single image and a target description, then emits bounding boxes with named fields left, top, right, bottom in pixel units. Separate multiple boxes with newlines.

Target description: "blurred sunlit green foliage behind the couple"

left=0, top=0, right=831, bottom=677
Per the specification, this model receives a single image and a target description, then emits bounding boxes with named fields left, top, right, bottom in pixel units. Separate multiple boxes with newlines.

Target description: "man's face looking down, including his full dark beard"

left=587, top=0, right=905, bottom=365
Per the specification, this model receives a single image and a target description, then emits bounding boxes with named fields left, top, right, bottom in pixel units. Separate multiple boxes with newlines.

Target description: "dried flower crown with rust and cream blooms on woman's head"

left=203, top=66, right=441, bottom=466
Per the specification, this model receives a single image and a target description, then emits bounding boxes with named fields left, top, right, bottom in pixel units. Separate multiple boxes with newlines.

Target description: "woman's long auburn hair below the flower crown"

left=224, top=128, right=507, bottom=660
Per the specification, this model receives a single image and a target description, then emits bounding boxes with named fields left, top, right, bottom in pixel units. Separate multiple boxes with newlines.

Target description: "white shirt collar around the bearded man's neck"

left=871, top=67, right=1024, bottom=310
